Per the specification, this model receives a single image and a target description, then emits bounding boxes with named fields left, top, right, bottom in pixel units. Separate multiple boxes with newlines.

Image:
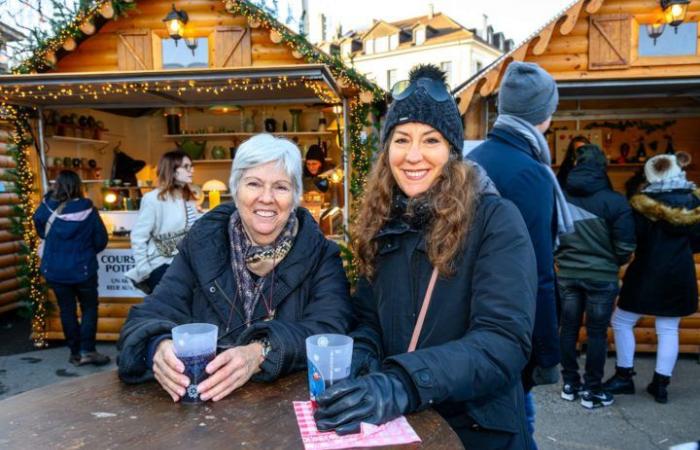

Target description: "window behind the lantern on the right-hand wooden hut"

left=639, top=22, right=698, bottom=56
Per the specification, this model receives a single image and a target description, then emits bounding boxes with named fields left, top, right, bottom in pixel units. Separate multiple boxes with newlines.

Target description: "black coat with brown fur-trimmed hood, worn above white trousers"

left=618, top=190, right=700, bottom=317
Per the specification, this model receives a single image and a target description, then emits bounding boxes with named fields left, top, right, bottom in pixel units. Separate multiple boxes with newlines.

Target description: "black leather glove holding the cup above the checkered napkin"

left=314, top=372, right=409, bottom=435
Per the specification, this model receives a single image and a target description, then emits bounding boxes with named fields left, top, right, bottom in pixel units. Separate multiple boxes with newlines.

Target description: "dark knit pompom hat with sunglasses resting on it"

left=381, top=64, right=464, bottom=155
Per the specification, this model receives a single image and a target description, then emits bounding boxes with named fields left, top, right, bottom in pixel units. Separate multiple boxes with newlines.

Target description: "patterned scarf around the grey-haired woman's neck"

left=229, top=211, right=299, bottom=326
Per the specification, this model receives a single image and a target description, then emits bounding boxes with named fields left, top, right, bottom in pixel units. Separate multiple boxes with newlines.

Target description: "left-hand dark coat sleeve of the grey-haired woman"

left=117, top=246, right=195, bottom=383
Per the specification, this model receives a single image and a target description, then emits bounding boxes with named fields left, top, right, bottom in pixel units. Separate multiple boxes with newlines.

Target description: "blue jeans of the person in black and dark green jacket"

left=557, top=278, right=619, bottom=390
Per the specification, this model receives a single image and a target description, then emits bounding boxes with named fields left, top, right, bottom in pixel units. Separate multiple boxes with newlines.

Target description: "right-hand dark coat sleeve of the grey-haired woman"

left=238, top=240, right=352, bottom=381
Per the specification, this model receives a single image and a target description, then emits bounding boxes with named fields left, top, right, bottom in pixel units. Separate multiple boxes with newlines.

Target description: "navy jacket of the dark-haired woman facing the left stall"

left=34, top=195, right=108, bottom=284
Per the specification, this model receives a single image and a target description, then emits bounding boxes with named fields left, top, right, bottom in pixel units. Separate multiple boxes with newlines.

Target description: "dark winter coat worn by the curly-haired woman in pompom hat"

left=351, top=195, right=537, bottom=449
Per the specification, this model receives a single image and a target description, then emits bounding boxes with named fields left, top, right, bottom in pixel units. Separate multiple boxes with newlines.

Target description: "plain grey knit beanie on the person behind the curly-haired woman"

left=498, top=61, right=559, bottom=125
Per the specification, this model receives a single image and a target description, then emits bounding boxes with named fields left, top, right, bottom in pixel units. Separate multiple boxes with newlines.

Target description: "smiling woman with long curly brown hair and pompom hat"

left=315, top=65, right=537, bottom=449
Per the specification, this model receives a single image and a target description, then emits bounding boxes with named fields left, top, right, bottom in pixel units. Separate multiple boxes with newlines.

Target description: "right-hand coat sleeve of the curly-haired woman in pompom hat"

left=385, top=201, right=537, bottom=409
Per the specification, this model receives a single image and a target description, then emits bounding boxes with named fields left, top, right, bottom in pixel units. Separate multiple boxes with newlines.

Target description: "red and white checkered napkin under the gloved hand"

left=294, top=402, right=421, bottom=450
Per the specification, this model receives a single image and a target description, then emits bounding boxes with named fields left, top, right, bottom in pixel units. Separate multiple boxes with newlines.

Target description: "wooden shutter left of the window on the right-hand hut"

left=588, top=14, right=632, bottom=70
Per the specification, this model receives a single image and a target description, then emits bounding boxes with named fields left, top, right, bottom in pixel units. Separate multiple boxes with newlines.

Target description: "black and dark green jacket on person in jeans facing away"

left=556, top=156, right=635, bottom=281
